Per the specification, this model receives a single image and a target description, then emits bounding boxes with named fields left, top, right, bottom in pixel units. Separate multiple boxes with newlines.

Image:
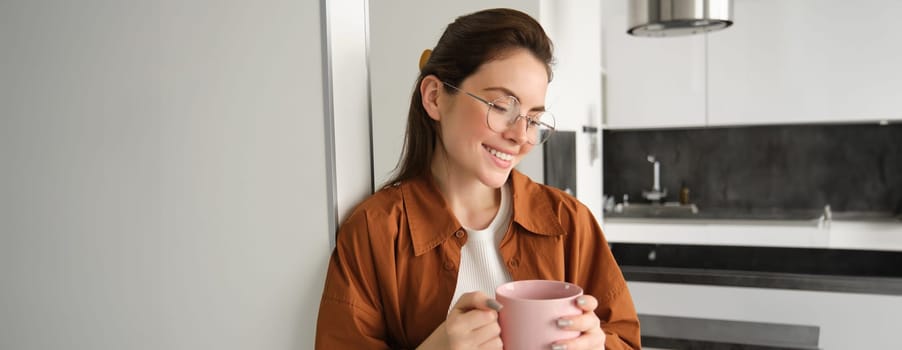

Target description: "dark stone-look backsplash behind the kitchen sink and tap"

left=604, top=124, right=902, bottom=214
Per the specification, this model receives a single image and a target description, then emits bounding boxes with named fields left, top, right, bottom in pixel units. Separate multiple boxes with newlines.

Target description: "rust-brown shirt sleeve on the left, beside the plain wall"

left=316, top=212, right=390, bottom=349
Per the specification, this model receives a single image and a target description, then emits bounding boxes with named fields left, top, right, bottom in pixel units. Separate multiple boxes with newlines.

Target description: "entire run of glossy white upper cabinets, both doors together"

left=602, top=0, right=902, bottom=129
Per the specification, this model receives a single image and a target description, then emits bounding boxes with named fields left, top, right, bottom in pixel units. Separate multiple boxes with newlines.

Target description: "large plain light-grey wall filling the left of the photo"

left=0, top=0, right=329, bottom=350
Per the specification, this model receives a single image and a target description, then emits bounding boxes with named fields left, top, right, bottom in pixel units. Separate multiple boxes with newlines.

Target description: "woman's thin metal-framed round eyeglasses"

left=442, top=82, right=554, bottom=145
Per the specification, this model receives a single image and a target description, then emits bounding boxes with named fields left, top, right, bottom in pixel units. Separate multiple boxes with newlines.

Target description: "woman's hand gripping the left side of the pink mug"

left=417, top=292, right=504, bottom=350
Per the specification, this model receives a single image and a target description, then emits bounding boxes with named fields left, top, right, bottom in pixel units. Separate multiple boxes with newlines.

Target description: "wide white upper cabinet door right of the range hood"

left=707, top=0, right=902, bottom=125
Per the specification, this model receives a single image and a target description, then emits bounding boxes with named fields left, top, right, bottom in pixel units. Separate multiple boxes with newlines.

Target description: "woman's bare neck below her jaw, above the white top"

left=432, top=151, right=501, bottom=229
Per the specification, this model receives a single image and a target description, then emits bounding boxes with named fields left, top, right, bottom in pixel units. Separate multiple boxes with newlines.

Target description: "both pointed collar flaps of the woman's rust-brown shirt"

left=398, top=170, right=565, bottom=256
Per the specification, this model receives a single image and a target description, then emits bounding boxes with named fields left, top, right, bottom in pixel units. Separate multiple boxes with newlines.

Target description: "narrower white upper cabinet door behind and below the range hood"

left=602, top=0, right=705, bottom=129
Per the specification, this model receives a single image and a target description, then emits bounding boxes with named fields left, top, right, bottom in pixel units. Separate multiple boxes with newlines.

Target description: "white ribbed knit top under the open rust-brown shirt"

left=448, top=183, right=513, bottom=312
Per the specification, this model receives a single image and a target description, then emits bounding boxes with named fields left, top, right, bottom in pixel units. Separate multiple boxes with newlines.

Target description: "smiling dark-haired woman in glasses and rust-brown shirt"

left=316, top=9, right=639, bottom=350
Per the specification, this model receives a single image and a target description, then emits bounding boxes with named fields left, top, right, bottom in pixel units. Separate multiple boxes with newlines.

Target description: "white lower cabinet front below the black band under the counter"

left=629, top=282, right=902, bottom=350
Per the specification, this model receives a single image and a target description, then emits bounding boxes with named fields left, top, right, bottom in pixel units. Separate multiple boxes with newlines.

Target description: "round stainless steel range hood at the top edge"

left=621, top=0, right=733, bottom=37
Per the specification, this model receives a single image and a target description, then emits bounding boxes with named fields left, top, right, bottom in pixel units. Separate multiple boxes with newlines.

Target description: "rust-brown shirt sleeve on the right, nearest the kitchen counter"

left=568, top=205, right=641, bottom=350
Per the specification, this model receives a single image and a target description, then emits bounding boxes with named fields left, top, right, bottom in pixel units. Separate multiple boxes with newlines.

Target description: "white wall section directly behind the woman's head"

left=369, top=0, right=541, bottom=186
